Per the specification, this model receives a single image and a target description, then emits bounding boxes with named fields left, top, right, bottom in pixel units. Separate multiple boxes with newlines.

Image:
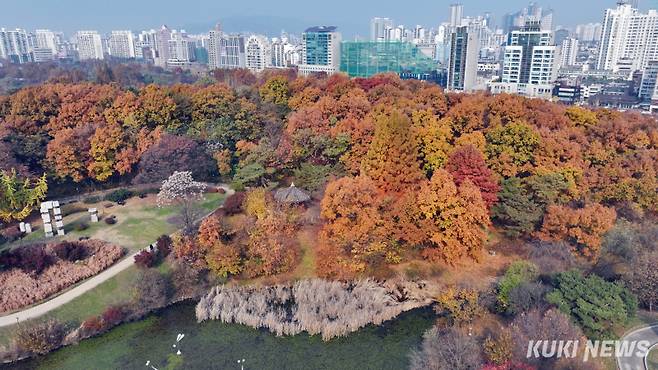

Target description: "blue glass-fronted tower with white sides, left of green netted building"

left=299, top=26, right=342, bottom=75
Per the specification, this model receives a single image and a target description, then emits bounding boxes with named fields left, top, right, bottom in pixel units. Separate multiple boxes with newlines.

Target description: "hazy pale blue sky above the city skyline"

left=0, top=0, right=658, bottom=38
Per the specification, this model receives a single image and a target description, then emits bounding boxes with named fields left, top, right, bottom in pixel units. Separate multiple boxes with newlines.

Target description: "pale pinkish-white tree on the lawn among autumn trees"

left=157, top=171, right=206, bottom=234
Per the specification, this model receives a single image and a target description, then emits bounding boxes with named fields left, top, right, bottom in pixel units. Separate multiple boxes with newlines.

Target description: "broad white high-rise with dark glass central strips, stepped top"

left=490, top=21, right=557, bottom=98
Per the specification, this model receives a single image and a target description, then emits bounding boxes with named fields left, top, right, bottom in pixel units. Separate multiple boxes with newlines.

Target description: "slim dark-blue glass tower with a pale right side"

left=447, top=26, right=480, bottom=91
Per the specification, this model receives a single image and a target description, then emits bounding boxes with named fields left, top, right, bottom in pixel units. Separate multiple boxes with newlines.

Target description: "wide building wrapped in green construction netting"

left=340, top=41, right=437, bottom=80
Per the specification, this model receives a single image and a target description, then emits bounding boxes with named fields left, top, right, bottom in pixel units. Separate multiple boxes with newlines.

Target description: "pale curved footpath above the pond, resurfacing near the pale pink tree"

left=0, top=185, right=235, bottom=327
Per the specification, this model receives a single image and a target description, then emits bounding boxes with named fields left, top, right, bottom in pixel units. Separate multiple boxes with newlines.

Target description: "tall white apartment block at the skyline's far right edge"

left=597, top=2, right=658, bottom=76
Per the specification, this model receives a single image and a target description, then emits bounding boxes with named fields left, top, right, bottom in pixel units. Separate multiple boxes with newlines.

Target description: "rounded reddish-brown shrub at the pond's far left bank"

left=14, top=320, right=65, bottom=355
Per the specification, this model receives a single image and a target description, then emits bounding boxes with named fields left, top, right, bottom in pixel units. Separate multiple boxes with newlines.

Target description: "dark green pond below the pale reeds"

left=6, top=302, right=435, bottom=370
